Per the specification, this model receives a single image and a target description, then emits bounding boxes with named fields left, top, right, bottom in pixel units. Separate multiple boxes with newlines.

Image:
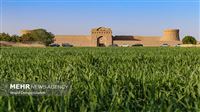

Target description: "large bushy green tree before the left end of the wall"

left=20, top=29, right=54, bottom=45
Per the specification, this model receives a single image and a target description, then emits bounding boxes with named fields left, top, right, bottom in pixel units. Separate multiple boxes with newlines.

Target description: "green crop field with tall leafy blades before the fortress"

left=0, top=47, right=200, bottom=112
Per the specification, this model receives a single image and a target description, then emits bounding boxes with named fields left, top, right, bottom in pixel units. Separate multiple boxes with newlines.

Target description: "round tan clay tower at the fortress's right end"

left=161, top=29, right=180, bottom=41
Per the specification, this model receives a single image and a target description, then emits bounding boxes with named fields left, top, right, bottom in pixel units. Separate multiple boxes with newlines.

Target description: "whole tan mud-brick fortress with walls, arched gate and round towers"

left=21, top=27, right=182, bottom=47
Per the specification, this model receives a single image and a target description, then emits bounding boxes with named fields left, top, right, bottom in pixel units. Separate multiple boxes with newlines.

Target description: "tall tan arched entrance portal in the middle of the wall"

left=91, top=27, right=112, bottom=47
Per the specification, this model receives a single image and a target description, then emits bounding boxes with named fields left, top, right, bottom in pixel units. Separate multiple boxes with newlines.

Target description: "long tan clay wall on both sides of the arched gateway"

left=54, top=35, right=182, bottom=47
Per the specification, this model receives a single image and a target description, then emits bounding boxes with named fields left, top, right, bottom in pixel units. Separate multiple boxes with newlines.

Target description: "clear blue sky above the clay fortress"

left=1, top=0, right=200, bottom=39
